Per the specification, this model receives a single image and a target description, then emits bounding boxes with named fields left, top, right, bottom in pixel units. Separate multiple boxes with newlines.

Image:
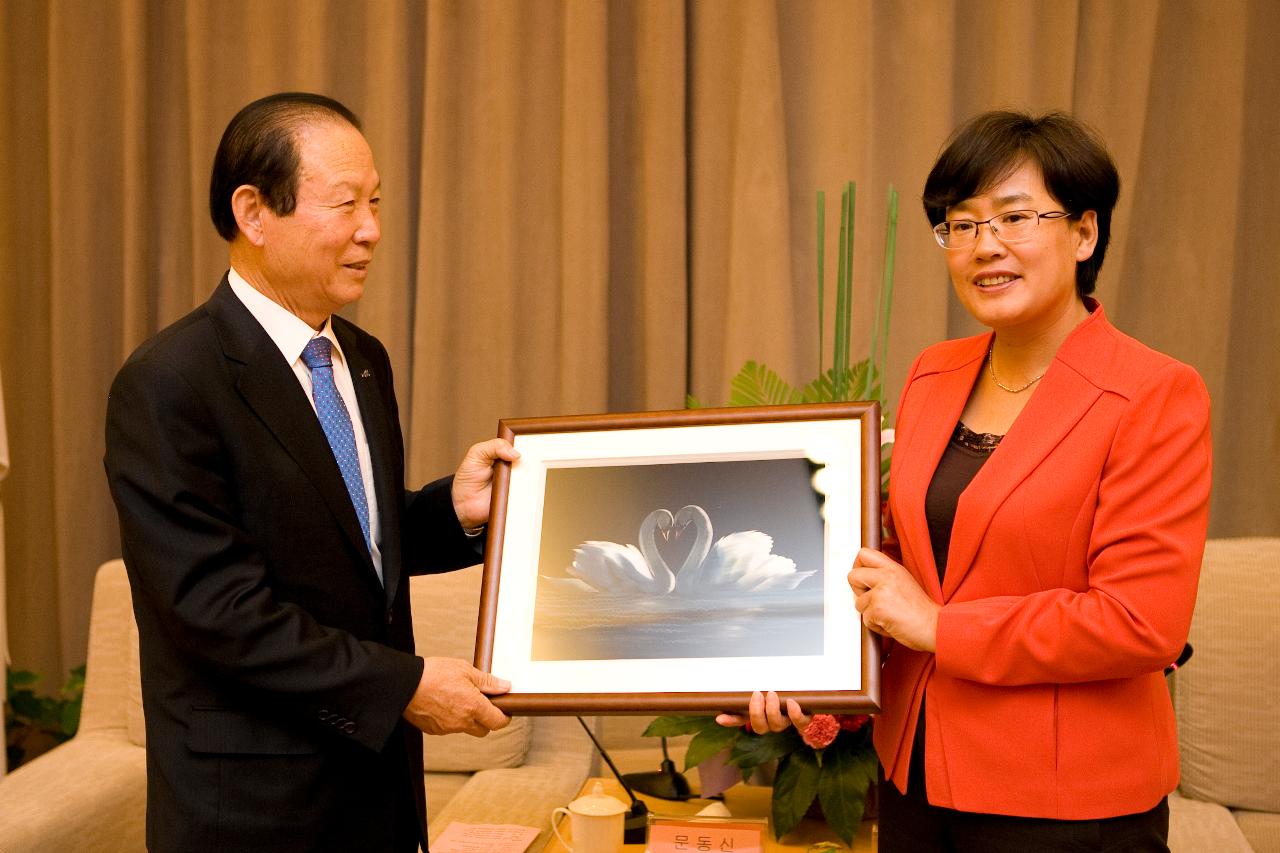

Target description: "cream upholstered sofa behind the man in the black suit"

left=0, top=560, right=594, bottom=853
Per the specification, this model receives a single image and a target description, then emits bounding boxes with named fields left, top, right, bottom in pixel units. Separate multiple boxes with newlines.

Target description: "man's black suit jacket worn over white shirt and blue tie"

left=105, top=277, right=477, bottom=853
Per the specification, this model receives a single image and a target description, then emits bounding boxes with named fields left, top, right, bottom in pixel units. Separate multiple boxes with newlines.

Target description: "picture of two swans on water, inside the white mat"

left=531, top=457, right=824, bottom=661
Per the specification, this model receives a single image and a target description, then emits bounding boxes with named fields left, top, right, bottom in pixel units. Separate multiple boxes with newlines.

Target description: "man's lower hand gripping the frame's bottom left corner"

left=404, top=657, right=511, bottom=738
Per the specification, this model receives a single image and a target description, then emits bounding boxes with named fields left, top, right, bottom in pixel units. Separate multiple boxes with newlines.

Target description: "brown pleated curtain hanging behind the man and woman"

left=0, top=0, right=1280, bottom=681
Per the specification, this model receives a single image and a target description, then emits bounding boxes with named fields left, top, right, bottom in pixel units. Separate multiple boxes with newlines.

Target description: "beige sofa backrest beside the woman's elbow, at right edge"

left=1174, top=539, right=1280, bottom=812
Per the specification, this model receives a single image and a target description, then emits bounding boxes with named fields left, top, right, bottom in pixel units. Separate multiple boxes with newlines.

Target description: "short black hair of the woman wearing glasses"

left=923, top=110, right=1120, bottom=297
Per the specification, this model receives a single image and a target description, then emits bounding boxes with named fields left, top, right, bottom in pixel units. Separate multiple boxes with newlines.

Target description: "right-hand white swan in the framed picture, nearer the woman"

left=673, top=505, right=815, bottom=594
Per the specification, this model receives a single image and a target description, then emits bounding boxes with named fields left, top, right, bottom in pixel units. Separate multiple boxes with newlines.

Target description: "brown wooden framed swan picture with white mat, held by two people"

left=475, top=402, right=881, bottom=715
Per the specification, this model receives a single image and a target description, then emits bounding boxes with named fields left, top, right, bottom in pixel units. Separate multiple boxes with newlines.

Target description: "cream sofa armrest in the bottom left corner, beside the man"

left=0, top=730, right=147, bottom=853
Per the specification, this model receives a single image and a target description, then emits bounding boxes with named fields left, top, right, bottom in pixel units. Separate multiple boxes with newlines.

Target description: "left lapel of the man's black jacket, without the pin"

left=209, top=277, right=374, bottom=575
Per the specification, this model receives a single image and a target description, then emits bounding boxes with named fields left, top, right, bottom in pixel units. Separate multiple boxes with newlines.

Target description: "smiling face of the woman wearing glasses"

left=943, top=160, right=1098, bottom=334
